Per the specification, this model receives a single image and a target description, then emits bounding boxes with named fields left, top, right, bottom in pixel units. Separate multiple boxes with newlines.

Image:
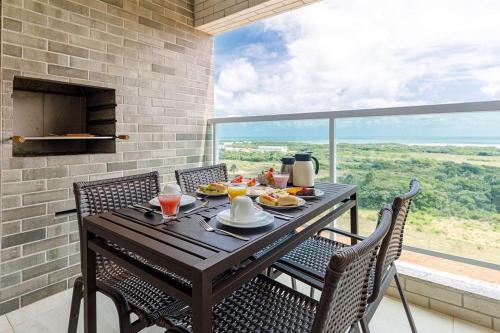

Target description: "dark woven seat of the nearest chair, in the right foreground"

left=167, top=275, right=318, bottom=333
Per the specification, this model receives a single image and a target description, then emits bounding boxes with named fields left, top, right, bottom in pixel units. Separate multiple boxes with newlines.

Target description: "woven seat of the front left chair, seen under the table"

left=96, top=246, right=187, bottom=327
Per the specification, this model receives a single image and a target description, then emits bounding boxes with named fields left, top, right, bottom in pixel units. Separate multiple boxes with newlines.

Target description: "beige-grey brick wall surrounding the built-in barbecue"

left=0, top=0, right=213, bottom=314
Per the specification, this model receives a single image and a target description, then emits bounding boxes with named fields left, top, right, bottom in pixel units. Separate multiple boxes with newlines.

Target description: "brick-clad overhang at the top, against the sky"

left=194, top=0, right=316, bottom=34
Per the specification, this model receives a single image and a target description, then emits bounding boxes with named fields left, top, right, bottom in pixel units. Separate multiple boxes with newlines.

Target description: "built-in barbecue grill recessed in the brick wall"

left=11, top=77, right=128, bottom=156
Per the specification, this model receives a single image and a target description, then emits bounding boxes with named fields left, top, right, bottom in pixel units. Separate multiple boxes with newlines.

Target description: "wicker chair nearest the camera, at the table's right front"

left=166, top=205, right=392, bottom=333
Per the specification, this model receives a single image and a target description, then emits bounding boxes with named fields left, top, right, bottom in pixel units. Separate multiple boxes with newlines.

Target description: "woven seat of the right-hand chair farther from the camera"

left=280, top=235, right=348, bottom=280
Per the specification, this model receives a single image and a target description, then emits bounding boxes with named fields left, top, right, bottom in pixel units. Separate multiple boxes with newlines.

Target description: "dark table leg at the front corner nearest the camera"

left=191, top=275, right=212, bottom=333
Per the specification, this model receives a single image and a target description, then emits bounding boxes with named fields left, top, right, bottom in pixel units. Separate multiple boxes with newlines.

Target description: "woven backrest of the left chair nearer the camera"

left=73, top=171, right=160, bottom=252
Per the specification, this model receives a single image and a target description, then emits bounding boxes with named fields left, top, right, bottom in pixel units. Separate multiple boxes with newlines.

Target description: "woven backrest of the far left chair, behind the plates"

left=175, top=163, right=227, bottom=193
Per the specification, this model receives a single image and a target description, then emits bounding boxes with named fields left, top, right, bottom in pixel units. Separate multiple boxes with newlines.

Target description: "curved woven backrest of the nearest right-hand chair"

left=312, top=205, right=392, bottom=333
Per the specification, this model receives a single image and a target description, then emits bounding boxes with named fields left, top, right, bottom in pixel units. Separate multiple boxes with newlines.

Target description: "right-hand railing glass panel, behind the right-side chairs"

left=335, top=112, right=500, bottom=264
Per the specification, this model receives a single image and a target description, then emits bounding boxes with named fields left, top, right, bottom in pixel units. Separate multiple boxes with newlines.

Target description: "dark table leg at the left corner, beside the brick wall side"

left=82, top=229, right=97, bottom=333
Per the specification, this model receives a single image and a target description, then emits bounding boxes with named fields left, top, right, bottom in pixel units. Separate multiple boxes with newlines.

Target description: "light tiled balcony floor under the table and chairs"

left=0, top=277, right=495, bottom=333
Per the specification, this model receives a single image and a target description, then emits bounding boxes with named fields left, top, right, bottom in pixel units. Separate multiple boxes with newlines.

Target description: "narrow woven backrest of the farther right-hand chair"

left=368, top=179, right=420, bottom=303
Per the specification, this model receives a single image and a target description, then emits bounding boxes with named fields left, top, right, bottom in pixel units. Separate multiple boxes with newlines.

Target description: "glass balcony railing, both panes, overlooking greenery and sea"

left=211, top=102, right=500, bottom=281
